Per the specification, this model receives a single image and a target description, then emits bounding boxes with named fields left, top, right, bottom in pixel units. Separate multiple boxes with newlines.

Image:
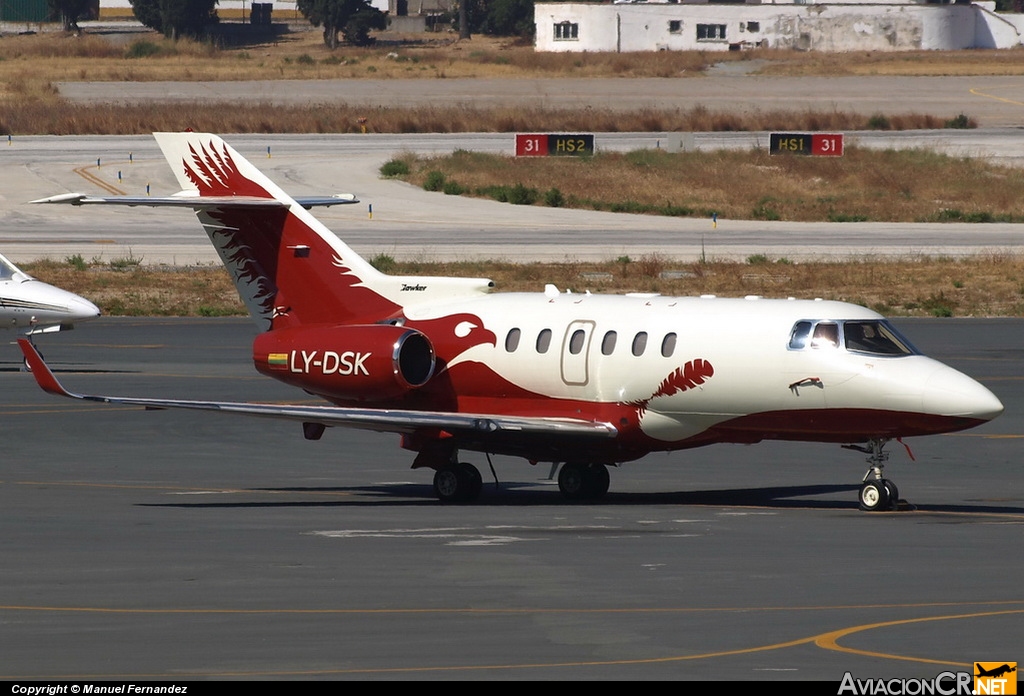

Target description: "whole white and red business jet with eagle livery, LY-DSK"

left=22, top=133, right=1002, bottom=510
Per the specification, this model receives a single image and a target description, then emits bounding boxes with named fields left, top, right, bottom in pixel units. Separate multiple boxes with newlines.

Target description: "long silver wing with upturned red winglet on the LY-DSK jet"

left=17, top=339, right=616, bottom=438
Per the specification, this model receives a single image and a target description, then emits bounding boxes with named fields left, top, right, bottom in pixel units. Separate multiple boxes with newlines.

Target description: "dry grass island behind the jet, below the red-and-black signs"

left=395, top=146, right=1024, bottom=222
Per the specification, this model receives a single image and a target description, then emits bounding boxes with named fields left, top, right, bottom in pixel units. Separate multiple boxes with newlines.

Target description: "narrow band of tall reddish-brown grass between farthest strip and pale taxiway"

left=0, top=100, right=958, bottom=135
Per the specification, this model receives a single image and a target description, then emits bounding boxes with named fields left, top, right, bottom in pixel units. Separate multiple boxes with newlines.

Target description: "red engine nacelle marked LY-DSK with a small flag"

left=253, top=324, right=434, bottom=401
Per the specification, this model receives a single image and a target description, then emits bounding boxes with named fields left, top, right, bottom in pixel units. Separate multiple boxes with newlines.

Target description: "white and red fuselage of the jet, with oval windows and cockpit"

left=284, top=293, right=1002, bottom=462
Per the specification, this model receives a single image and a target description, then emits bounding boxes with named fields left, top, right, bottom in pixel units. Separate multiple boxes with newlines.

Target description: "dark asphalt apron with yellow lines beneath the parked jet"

left=0, top=319, right=1024, bottom=683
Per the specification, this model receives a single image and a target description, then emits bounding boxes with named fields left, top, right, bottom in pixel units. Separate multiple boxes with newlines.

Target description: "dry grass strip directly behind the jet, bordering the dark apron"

left=24, top=253, right=1024, bottom=316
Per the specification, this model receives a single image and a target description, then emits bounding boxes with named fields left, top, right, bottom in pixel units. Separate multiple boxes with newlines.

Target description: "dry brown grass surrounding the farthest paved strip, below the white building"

left=0, top=32, right=1007, bottom=134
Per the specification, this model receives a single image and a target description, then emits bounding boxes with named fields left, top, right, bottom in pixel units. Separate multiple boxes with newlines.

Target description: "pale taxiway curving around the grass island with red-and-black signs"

left=6, top=128, right=1024, bottom=265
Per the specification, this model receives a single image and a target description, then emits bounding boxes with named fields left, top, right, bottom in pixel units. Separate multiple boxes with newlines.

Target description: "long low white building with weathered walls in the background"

left=534, top=0, right=1024, bottom=52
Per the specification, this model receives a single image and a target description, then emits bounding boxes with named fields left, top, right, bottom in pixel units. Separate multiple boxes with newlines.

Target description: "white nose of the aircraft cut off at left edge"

left=0, top=256, right=99, bottom=336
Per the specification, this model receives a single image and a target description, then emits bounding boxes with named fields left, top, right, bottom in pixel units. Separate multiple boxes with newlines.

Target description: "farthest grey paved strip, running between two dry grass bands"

left=56, top=76, right=1024, bottom=126
